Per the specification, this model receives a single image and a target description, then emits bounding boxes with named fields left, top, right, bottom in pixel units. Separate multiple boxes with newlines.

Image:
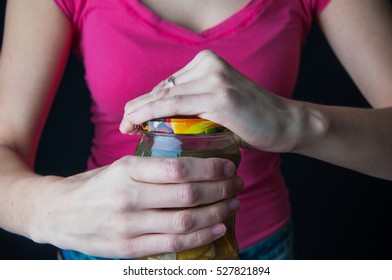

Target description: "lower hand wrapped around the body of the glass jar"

left=33, top=156, right=243, bottom=258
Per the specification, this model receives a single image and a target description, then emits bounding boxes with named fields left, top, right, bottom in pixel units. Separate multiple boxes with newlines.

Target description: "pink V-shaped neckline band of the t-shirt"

left=119, top=0, right=270, bottom=45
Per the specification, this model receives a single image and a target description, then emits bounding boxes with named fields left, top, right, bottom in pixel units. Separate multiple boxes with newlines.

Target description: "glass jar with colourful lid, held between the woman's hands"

left=135, top=117, right=240, bottom=260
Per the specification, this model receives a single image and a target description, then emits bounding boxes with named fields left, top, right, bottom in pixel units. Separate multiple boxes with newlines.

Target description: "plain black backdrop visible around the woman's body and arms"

left=0, top=1, right=392, bottom=259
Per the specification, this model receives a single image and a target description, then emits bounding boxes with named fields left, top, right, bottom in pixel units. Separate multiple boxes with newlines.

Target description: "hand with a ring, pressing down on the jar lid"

left=120, top=51, right=300, bottom=152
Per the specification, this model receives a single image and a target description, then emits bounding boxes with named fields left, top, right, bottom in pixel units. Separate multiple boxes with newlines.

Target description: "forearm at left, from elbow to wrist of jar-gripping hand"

left=0, top=145, right=58, bottom=242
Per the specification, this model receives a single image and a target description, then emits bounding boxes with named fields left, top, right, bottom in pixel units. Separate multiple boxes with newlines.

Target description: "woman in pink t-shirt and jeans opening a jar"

left=0, top=0, right=392, bottom=259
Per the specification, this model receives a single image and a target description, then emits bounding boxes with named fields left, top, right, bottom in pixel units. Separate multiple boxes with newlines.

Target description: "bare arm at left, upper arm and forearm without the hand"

left=0, top=0, right=72, bottom=236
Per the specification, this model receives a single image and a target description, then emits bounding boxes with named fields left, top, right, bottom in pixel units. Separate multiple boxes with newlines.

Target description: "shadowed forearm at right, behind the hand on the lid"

left=292, top=102, right=392, bottom=180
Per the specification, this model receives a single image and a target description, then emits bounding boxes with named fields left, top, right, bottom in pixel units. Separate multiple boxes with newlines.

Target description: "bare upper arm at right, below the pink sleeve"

left=320, top=0, right=392, bottom=108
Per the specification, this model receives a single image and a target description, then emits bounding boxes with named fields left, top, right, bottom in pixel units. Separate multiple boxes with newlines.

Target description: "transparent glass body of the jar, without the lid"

left=135, top=117, right=240, bottom=260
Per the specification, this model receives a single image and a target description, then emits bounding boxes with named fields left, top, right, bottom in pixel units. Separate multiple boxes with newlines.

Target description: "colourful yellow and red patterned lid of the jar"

left=140, top=116, right=228, bottom=135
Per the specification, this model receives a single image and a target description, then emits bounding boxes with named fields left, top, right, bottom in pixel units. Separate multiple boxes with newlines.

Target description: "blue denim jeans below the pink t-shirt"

left=59, top=221, right=294, bottom=260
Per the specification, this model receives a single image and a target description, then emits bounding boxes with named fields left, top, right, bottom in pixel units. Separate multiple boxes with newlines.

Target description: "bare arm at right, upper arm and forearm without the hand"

left=294, top=0, right=392, bottom=179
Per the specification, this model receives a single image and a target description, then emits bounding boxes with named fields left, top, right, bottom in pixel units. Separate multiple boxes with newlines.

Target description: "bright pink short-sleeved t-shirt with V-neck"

left=54, top=0, right=330, bottom=248
